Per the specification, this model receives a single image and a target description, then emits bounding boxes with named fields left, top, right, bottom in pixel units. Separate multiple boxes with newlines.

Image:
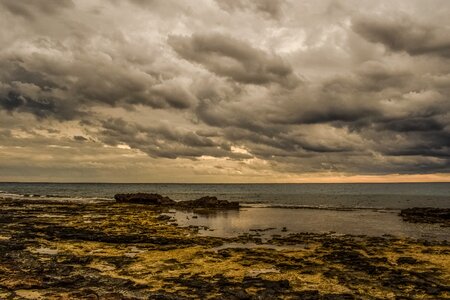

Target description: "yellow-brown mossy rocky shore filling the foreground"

left=0, top=199, right=450, bottom=299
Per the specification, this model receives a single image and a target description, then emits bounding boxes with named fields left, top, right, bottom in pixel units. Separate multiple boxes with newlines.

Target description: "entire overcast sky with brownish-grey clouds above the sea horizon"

left=0, top=0, right=450, bottom=183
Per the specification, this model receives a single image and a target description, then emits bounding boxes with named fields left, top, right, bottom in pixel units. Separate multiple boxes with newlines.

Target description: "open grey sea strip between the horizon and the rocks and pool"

left=0, top=183, right=450, bottom=209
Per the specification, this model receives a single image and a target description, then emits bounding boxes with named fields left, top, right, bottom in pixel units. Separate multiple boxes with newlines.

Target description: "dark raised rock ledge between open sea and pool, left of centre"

left=114, top=193, right=239, bottom=209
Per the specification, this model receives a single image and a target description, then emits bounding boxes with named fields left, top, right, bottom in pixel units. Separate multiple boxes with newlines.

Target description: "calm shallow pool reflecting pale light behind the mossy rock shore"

left=171, top=208, right=450, bottom=240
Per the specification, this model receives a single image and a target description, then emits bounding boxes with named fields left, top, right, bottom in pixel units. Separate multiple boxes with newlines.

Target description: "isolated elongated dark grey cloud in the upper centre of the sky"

left=168, top=34, right=298, bottom=87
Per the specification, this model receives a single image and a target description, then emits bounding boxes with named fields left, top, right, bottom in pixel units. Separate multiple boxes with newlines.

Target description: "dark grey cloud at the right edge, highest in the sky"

left=353, top=16, right=450, bottom=58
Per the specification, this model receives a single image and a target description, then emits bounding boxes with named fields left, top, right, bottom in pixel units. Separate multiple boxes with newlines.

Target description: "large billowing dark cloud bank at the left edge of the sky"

left=0, top=37, right=196, bottom=120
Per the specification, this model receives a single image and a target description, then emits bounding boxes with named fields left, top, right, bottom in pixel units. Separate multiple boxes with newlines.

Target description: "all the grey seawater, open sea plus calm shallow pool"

left=0, top=183, right=450, bottom=240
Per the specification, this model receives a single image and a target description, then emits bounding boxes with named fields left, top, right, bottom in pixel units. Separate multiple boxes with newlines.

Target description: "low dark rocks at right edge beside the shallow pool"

left=400, top=207, right=450, bottom=226
